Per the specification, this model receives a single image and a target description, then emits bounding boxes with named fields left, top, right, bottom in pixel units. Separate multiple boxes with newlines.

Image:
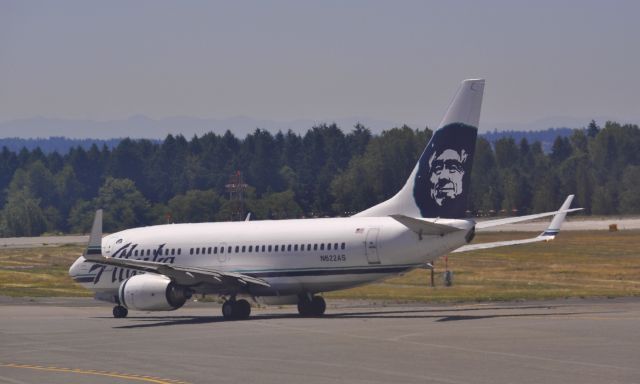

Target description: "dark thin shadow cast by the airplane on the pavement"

left=100, top=305, right=604, bottom=329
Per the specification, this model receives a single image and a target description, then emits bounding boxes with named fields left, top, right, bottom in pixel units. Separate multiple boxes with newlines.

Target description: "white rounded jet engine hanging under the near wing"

left=118, top=274, right=191, bottom=311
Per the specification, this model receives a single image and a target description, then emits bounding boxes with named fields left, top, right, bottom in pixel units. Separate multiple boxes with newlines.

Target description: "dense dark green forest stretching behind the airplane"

left=0, top=121, right=640, bottom=237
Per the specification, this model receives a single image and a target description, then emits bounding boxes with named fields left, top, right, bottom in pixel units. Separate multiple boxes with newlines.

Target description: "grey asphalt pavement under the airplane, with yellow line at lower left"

left=0, top=298, right=640, bottom=384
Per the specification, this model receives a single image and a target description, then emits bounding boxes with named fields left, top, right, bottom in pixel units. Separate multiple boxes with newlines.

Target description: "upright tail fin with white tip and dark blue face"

left=355, top=79, right=484, bottom=219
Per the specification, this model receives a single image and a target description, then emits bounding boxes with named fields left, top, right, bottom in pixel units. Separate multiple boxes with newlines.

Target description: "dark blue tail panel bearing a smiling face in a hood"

left=413, top=124, right=477, bottom=218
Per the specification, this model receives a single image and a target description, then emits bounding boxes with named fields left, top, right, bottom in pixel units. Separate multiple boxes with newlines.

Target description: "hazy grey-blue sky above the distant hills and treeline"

left=0, top=0, right=640, bottom=128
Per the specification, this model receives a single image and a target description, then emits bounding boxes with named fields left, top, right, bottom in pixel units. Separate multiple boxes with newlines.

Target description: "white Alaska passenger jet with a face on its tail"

left=69, top=79, right=581, bottom=320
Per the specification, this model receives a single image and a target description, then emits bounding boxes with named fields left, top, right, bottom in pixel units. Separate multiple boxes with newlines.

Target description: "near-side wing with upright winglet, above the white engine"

left=83, top=209, right=270, bottom=288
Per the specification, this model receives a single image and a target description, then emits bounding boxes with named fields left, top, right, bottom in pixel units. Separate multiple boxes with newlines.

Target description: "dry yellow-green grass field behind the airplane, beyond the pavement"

left=0, top=230, right=640, bottom=302
